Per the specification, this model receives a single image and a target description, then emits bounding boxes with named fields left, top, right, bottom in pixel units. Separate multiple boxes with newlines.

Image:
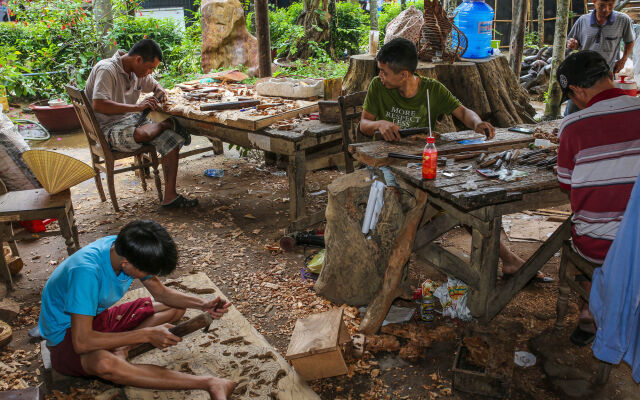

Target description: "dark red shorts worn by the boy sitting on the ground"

left=49, top=297, right=154, bottom=376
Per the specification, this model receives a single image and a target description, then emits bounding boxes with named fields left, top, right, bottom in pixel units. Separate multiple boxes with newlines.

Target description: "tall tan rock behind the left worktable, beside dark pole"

left=200, top=0, right=258, bottom=73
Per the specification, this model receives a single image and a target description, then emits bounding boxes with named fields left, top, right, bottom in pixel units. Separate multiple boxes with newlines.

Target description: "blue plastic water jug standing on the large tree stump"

left=453, top=0, right=495, bottom=58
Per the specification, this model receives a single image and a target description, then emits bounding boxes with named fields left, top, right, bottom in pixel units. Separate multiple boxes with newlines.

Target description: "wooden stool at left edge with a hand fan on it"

left=0, top=189, right=80, bottom=289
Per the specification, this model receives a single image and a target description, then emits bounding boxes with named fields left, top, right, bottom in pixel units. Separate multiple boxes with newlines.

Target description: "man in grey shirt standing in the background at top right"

left=565, top=0, right=635, bottom=115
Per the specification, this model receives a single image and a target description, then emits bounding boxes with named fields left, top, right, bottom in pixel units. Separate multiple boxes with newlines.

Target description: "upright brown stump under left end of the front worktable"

left=314, top=170, right=411, bottom=306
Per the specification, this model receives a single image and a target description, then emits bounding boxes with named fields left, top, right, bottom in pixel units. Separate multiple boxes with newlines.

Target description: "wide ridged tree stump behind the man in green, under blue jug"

left=342, top=54, right=535, bottom=128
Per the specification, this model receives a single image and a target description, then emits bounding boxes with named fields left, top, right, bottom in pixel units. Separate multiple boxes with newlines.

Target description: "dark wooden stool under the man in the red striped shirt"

left=555, top=240, right=611, bottom=385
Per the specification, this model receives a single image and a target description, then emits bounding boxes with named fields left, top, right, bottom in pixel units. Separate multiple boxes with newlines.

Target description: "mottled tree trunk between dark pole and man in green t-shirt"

left=289, top=0, right=330, bottom=59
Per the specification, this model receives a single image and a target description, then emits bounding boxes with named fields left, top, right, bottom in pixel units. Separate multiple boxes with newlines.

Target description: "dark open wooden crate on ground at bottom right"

left=452, top=340, right=513, bottom=398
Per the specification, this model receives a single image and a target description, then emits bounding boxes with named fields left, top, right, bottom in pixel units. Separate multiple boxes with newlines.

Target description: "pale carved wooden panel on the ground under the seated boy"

left=121, top=273, right=319, bottom=400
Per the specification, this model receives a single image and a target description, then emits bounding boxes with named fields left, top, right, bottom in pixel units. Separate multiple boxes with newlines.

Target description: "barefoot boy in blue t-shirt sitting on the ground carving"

left=39, top=221, right=235, bottom=400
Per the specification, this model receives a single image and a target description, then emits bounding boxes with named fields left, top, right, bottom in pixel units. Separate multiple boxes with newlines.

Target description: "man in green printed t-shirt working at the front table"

left=360, top=38, right=495, bottom=141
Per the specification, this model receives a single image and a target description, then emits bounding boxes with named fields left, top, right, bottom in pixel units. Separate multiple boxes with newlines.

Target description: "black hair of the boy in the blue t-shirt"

left=114, top=220, right=178, bottom=276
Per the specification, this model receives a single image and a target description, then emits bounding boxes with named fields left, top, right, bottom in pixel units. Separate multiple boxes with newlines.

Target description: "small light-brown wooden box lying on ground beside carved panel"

left=285, top=309, right=350, bottom=381
